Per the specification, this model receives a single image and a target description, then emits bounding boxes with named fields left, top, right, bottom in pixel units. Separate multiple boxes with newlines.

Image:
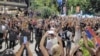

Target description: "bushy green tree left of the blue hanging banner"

left=31, top=0, right=58, bottom=18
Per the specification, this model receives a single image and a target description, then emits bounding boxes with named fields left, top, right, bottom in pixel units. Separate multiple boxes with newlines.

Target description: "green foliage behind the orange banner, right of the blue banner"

left=67, top=0, right=100, bottom=14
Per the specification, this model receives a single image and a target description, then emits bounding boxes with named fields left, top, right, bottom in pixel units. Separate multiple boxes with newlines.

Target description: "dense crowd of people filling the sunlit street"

left=0, top=13, right=100, bottom=56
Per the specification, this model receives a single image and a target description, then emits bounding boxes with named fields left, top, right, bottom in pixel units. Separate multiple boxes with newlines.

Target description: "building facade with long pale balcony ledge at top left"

left=0, top=0, right=28, bottom=14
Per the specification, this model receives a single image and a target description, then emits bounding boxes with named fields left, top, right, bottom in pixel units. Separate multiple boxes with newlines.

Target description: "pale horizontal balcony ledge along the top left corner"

left=0, top=0, right=27, bottom=7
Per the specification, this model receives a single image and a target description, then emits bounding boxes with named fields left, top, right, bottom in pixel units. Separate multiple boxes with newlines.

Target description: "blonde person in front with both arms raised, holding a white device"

left=40, top=31, right=64, bottom=56
